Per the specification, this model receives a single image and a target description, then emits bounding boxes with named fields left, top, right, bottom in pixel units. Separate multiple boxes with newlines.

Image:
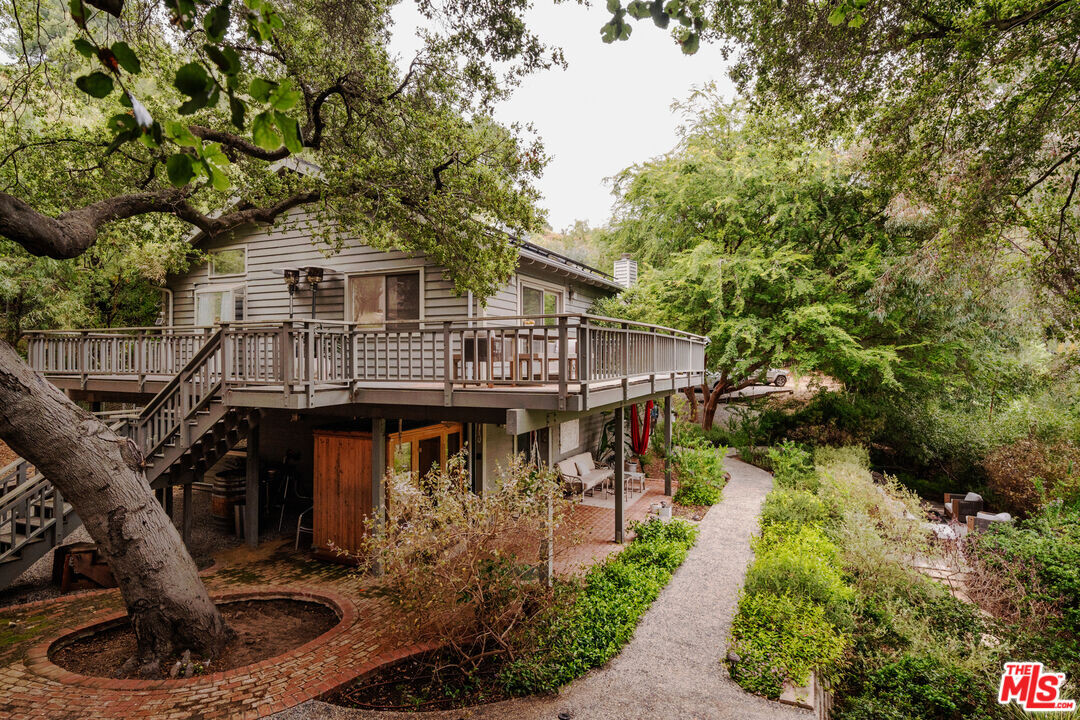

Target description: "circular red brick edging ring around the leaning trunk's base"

left=26, top=585, right=357, bottom=690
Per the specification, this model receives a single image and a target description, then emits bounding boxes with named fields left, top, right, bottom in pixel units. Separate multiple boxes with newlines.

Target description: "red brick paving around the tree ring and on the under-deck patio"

left=0, top=480, right=664, bottom=720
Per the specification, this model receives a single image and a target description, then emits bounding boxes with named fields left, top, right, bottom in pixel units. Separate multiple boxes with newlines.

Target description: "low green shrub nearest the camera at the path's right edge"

left=729, top=592, right=847, bottom=699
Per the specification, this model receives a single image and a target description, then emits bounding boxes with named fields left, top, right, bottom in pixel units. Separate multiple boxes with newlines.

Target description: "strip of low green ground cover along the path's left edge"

left=499, top=519, right=698, bottom=695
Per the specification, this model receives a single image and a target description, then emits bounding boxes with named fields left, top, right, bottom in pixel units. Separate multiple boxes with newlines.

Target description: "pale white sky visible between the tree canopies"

left=392, top=0, right=734, bottom=230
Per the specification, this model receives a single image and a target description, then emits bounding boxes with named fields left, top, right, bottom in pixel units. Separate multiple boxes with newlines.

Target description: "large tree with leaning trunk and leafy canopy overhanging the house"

left=0, top=0, right=562, bottom=671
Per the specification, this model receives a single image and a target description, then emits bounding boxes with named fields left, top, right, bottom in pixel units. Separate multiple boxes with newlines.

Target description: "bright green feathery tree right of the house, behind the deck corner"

left=603, top=99, right=920, bottom=427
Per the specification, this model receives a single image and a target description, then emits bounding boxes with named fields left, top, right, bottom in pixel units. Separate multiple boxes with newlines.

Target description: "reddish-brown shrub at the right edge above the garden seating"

left=983, top=435, right=1080, bottom=515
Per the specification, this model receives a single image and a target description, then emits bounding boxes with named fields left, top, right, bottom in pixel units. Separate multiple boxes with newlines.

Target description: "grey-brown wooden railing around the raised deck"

left=28, top=314, right=707, bottom=405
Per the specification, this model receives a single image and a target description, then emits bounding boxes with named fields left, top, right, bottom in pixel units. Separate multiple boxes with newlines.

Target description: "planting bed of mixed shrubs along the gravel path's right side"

left=728, top=444, right=1000, bottom=720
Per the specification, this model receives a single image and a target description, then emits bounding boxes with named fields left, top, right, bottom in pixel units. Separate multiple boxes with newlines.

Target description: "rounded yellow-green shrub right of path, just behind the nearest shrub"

left=743, top=525, right=854, bottom=624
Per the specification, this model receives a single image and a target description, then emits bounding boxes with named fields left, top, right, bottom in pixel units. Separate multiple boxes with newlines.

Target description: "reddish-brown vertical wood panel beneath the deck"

left=313, top=430, right=372, bottom=551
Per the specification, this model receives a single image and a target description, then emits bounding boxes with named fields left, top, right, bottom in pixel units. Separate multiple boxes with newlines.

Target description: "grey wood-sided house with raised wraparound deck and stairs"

left=8, top=217, right=706, bottom=580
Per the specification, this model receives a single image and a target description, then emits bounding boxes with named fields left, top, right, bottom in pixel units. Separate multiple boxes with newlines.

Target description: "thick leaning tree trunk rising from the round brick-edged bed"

left=0, top=342, right=231, bottom=673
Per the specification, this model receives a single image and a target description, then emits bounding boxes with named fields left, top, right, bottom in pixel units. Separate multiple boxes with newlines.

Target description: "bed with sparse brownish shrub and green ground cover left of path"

left=335, top=459, right=698, bottom=709
